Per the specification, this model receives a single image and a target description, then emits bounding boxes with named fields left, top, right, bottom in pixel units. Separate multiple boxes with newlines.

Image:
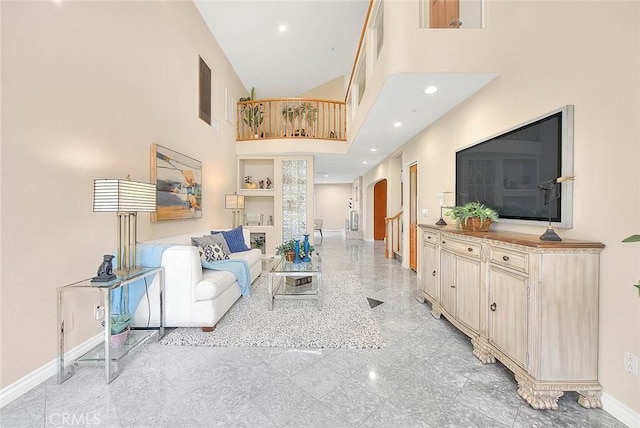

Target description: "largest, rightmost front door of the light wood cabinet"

left=489, top=266, right=529, bottom=369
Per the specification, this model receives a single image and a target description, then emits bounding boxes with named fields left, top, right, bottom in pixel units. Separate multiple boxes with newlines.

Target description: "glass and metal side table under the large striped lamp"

left=57, top=267, right=164, bottom=383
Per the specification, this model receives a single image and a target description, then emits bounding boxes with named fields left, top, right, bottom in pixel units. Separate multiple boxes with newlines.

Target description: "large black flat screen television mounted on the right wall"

left=456, top=105, right=573, bottom=228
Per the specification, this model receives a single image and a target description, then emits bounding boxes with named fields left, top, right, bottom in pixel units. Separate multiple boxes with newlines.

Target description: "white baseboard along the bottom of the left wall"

left=0, top=333, right=104, bottom=409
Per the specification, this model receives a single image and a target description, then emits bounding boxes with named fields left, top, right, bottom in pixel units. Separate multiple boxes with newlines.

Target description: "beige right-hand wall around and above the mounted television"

left=363, top=0, right=640, bottom=414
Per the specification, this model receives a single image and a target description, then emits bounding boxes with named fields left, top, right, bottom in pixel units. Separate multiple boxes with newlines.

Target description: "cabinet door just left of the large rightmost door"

left=455, top=256, right=482, bottom=332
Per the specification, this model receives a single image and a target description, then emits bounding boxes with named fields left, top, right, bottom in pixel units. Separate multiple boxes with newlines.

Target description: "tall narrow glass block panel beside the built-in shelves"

left=282, top=160, right=307, bottom=242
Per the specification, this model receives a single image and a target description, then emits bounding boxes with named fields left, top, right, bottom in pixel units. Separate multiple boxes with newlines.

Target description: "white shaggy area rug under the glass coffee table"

left=160, top=272, right=385, bottom=348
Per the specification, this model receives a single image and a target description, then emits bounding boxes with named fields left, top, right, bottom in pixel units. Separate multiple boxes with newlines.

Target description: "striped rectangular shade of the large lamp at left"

left=93, top=179, right=156, bottom=212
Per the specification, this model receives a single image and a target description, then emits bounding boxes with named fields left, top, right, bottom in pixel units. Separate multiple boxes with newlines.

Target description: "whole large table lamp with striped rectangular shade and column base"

left=93, top=176, right=156, bottom=274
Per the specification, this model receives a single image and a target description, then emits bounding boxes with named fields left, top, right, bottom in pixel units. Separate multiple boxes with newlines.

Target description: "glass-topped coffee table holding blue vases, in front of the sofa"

left=267, top=260, right=322, bottom=311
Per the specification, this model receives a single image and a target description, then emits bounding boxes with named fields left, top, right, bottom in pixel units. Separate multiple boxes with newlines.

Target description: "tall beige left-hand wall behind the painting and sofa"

left=0, top=1, right=246, bottom=387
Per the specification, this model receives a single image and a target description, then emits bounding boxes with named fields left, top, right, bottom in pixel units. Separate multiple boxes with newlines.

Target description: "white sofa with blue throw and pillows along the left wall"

left=133, top=229, right=262, bottom=328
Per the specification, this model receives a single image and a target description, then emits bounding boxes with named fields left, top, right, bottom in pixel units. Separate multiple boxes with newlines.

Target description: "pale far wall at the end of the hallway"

left=313, top=184, right=352, bottom=230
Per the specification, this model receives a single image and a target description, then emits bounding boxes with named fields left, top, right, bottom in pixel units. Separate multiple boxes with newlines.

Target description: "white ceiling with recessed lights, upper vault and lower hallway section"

left=194, top=0, right=497, bottom=184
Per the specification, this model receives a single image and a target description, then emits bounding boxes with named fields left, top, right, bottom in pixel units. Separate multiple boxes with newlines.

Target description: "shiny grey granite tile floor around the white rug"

left=0, top=232, right=624, bottom=428
